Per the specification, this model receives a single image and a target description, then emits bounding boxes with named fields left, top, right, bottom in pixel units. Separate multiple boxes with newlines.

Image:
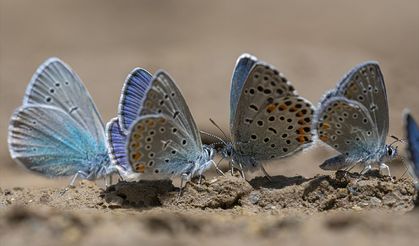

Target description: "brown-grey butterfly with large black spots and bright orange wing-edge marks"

left=221, top=54, right=314, bottom=177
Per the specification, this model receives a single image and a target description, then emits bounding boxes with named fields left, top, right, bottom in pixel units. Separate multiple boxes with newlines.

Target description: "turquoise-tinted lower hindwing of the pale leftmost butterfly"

left=8, top=105, right=108, bottom=178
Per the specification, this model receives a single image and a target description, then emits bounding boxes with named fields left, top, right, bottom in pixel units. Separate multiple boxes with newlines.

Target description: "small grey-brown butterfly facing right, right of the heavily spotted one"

left=313, top=62, right=397, bottom=176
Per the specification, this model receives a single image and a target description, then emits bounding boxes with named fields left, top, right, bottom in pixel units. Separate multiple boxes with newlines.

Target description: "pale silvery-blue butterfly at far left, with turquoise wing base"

left=8, top=58, right=116, bottom=185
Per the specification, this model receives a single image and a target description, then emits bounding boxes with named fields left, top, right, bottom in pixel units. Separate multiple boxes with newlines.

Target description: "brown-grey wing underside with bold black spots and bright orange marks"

left=232, top=62, right=313, bottom=160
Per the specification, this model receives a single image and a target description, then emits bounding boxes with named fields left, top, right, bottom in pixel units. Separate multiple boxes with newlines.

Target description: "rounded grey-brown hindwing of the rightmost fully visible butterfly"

left=313, top=97, right=381, bottom=162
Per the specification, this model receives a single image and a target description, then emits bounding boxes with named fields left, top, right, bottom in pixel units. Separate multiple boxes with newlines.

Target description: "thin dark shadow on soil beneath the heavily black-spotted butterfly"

left=249, top=175, right=312, bottom=189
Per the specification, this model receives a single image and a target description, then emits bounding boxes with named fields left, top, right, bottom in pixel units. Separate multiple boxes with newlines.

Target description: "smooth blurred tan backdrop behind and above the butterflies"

left=0, top=0, right=419, bottom=187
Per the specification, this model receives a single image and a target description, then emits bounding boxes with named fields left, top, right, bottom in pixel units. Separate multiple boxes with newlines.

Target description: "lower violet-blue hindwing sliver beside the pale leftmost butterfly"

left=106, top=118, right=131, bottom=171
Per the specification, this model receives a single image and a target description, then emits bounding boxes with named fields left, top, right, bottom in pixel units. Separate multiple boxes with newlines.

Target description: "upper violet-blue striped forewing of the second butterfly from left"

left=118, top=68, right=152, bottom=134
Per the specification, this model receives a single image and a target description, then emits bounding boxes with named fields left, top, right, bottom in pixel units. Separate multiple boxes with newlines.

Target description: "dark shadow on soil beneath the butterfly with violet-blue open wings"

left=101, top=180, right=178, bottom=209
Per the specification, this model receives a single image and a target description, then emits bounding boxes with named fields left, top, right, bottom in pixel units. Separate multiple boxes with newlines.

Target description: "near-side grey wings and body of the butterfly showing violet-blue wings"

left=121, top=71, right=214, bottom=181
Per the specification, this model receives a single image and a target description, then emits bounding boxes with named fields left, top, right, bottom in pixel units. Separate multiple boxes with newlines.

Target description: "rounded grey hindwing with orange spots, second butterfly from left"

left=127, top=114, right=202, bottom=179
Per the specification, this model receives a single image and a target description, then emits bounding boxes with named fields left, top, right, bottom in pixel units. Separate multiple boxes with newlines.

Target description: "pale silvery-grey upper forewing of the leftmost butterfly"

left=23, top=58, right=105, bottom=141
